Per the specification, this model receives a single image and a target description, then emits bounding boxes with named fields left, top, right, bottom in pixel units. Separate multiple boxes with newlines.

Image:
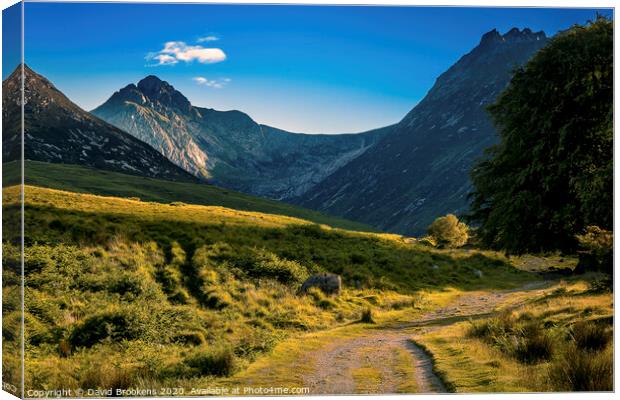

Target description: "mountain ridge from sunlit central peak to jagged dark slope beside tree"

left=7, top=28, right=547, bottom=238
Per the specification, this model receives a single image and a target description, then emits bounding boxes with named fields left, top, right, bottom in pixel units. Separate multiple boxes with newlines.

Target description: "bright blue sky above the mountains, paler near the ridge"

left=9, top=3, right=611, bottom=133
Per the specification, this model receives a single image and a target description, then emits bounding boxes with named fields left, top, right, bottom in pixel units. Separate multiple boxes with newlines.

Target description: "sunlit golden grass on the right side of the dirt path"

left=415, top=280, right=613, bottom=392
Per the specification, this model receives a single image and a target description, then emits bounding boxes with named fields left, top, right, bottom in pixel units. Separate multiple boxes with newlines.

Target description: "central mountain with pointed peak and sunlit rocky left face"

left=92, top=75, right=391, bottom=200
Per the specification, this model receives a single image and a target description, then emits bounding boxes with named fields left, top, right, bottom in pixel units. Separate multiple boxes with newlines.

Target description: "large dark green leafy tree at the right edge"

left=470, top=18, right=613, bottom=253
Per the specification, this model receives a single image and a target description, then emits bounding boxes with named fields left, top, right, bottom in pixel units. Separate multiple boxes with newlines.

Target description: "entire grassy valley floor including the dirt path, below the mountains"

left=3, top=185, right=613, bottom=396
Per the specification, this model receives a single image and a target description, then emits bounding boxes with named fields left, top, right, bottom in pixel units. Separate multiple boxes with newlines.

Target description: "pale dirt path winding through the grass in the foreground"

left=304, top=282, right=548, bottom=394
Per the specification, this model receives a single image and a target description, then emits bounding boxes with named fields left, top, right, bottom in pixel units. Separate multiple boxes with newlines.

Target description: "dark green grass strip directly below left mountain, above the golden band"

left=3, top=161, right=376, bottom=232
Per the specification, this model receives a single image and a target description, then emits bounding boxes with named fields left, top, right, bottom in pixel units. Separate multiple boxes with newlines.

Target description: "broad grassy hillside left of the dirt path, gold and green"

left=3, top=186, right=532, bottom=389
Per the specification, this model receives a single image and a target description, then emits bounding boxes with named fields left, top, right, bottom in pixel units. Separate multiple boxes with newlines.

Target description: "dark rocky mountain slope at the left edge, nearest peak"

left=2, top=65, right=197, bottom=182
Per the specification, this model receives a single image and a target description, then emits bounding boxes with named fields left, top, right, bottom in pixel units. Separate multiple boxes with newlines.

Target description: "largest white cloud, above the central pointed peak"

left=146, top=41, right=226, bottom=65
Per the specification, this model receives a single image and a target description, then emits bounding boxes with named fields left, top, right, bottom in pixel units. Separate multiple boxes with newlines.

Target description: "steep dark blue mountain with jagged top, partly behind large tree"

left=292, top=28, right=547, bottom=234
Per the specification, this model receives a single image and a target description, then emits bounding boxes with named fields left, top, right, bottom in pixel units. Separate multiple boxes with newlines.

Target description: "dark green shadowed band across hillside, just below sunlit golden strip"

left=10, top=204, right=539, bottom=293
